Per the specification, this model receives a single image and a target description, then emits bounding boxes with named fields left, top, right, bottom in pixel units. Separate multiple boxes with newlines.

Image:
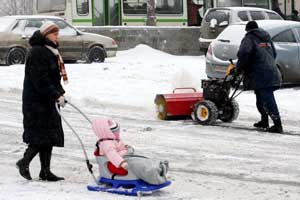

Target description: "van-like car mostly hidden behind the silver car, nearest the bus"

left=199, top=7, right=283, bottom=53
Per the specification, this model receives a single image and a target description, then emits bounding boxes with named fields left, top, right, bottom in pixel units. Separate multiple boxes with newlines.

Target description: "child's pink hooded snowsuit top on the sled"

left=92, top=119, right=127, bottom=167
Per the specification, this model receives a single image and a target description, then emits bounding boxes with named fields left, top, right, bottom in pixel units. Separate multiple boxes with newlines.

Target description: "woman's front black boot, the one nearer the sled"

left=39, top=148, right=64, bottom=181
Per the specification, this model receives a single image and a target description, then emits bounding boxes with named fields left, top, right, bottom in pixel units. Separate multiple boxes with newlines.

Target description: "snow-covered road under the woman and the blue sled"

left=0, top=90, right=300, bottom=199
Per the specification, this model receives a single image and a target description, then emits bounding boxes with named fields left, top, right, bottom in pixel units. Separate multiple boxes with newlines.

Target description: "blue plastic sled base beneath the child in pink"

left=87, top=177, right=171, bottom=196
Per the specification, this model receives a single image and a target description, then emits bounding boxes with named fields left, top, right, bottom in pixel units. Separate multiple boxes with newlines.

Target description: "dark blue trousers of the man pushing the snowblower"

left=254, top=87, right=280, bottom=121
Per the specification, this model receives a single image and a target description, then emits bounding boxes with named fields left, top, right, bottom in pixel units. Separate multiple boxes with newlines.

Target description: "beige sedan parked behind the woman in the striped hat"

left=0, top=15, right=118, bottom=65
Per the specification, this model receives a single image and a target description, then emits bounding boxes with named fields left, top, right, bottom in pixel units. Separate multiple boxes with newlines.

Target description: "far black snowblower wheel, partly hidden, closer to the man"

left=219, top=99, right=240, bottom=123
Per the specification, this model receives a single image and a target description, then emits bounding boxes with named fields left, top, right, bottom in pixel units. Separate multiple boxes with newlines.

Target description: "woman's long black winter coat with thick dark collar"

left=22, top=31, right=65, bottom=147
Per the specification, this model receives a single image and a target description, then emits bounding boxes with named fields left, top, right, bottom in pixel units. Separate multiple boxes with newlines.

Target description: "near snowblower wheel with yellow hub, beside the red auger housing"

left=194, top=100, right=218, bottom=125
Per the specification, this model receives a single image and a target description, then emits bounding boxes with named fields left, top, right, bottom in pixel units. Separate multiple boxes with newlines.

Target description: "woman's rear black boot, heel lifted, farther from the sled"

left=16, top=145, right=39, bottom=180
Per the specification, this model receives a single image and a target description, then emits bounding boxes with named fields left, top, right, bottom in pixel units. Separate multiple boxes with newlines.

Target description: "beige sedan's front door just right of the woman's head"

left=48, top=19, right=83, bottom=61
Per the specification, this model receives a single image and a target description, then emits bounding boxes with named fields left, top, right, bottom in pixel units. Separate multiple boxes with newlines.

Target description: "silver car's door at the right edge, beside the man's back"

left=272, top=28, right=300, bottom=82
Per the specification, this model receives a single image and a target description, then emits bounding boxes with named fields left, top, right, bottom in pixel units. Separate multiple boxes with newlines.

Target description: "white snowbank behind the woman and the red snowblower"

left=0, top=45, right=205, bottom=108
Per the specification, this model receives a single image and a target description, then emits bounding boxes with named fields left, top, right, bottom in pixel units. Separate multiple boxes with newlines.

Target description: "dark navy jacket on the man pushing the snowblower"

left=236, top=28, right=281, bottom=90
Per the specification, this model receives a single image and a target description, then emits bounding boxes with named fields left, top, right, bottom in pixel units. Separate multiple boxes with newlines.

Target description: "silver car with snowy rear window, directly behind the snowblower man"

left=206, top=20, right=300, bottom=84
